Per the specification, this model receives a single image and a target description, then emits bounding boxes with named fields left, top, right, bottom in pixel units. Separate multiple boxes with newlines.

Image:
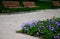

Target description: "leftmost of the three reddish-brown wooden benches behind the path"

left=2, top=1, right=21, bottom=8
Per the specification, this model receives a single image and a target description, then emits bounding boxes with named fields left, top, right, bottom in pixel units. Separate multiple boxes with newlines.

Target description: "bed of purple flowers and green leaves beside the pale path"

left=17, top=18, right=60, bottom=39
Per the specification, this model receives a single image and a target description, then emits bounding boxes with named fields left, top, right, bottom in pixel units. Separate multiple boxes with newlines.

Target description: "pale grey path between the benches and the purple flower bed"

left=0, top=9, right=60, bottom=39
